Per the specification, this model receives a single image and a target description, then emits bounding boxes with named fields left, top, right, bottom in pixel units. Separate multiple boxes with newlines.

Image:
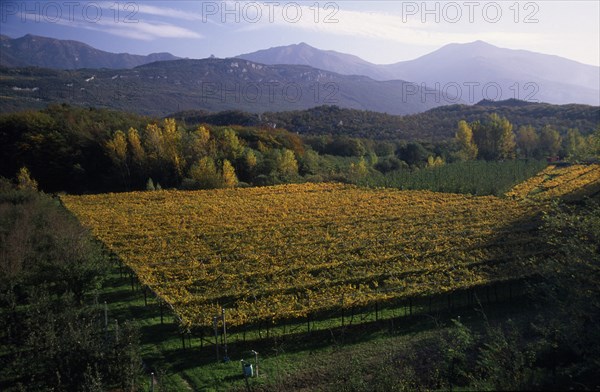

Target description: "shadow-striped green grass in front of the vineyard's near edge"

left=100, top=264, right=525, bottom=391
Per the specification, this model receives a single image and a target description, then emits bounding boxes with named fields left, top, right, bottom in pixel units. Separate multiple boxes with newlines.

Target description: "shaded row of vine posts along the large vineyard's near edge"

left=108, top=253, right=535, bottom=361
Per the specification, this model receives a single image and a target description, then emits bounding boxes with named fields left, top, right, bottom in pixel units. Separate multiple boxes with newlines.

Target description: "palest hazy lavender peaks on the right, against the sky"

left=238, top=41, right=600, bottom=105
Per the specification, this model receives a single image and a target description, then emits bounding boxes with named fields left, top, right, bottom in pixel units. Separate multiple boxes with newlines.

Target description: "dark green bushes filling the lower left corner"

left=0, top=182, right=141, bottom=391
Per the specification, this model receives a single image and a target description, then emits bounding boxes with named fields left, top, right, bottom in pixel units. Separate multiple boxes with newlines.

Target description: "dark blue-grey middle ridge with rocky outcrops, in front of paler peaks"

left=0, top=58, right=447, bottom=115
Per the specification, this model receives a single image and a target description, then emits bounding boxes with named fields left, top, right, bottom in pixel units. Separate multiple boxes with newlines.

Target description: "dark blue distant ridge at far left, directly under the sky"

left=0, top=34, right=179, bottom=69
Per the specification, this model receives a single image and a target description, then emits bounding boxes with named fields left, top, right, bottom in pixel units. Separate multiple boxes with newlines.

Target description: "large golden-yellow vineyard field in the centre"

left=62, top=184, right=543, bottom=326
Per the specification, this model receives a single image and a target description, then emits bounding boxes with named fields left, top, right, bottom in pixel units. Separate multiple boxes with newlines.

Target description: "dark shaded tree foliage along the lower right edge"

left=534, top=199, right=600, bottom=389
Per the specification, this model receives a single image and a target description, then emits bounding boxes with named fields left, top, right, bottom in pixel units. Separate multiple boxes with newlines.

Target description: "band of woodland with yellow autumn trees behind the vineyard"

left=0, top=105, right=600, bottom=194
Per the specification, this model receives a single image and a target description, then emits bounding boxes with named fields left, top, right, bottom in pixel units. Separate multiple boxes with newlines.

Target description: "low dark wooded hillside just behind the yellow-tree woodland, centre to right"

left=172, top=100, right=600, bottom=141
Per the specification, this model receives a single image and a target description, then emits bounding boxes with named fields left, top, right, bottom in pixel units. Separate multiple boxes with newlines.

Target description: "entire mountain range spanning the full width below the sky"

left=0, top=35, right=600, bottom=115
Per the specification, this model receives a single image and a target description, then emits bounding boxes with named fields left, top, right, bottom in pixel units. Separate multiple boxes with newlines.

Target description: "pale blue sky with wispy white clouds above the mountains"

left=0, top=0, right=600, bottom=65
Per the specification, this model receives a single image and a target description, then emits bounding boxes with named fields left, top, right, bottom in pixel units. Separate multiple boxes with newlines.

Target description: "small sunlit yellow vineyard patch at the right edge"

left=506, top=165, right=600, bottom=201
